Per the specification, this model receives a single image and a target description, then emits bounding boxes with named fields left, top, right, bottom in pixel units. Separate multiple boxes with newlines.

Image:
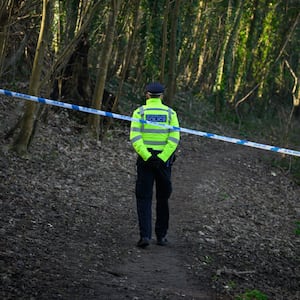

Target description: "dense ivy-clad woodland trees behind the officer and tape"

left=0, top=0, right=300, bottom=173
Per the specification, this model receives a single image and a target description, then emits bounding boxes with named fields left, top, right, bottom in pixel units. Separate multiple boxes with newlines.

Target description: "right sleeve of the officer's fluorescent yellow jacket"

left=157, top=110, right=180, bottom=162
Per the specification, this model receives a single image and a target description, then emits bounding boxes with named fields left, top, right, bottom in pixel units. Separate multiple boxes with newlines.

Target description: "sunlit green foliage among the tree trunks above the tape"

left=0, top=0, right=300, bottom=146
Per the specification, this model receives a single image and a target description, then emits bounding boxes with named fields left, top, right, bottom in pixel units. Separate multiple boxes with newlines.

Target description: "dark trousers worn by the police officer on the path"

left=135, top=157, right=172, bottom=239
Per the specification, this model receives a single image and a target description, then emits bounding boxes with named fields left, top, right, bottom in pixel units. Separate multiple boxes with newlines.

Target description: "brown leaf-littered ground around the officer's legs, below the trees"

left=0, top=97, right=300, bottom=300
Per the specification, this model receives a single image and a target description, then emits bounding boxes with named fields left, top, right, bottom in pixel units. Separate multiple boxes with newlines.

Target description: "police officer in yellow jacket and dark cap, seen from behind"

left=130, top=82, right=180, bottom=248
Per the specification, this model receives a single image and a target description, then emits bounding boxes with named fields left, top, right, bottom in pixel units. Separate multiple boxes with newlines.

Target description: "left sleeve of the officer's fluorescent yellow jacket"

left=130, top=109, right=152, bottom=161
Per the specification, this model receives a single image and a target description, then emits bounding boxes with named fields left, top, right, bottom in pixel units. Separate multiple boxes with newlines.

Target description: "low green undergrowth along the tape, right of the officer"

left=174, top=93, right=300, bottom=185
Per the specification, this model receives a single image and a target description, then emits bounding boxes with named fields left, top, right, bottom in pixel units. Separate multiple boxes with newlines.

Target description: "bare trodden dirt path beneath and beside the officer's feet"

left=86, top=137, right=218, bottom=300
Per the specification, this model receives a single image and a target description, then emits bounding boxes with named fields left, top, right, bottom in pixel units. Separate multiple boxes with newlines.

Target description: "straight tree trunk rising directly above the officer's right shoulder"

left=165, top=0, right=180, bottom=105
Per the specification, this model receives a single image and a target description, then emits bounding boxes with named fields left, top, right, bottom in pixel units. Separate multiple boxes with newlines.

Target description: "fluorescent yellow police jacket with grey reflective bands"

left=130, top=98, right=180, bottom=162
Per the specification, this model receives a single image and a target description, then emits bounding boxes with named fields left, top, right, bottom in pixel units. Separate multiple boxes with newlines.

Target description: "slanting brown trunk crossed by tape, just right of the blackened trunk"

left=89, top=0, right=122, bottom=139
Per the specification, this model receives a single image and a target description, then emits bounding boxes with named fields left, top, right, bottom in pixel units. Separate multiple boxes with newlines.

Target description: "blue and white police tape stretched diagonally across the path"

left=0, top=89, right=300, bottom=157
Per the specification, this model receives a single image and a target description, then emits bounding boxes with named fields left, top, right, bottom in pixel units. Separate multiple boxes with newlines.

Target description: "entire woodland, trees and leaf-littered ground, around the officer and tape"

left=0, top=0, right=300, bottom=300
